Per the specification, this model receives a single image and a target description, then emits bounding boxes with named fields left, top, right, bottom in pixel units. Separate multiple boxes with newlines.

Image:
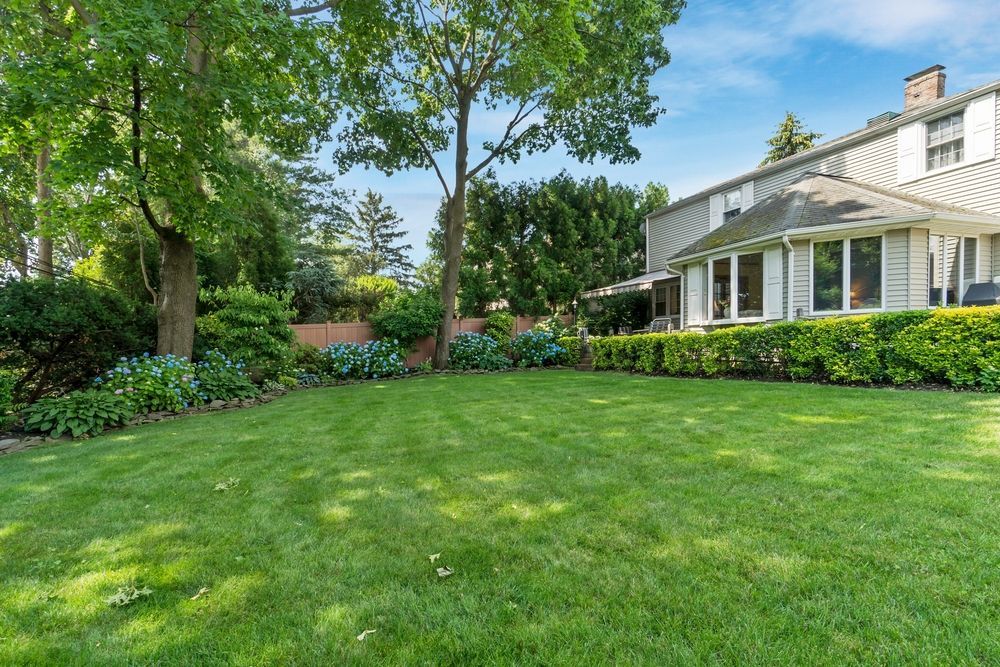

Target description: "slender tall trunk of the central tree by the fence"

left=434, top=101, right=471, bottom=370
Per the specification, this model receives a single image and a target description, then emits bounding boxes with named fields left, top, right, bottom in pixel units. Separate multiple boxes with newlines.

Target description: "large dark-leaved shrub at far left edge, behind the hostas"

left=0, top=279, right=156, bottom=403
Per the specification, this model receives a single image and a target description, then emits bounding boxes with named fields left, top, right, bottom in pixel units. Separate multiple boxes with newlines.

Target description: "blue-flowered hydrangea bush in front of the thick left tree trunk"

left=94, top=353, right=208, bottom=413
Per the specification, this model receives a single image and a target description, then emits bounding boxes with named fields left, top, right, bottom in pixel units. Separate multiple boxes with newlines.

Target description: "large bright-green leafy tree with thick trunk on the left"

left=0, top=0, right=335, bottom=355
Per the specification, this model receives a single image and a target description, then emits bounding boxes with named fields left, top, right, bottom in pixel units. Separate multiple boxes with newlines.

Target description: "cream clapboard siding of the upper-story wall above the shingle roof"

left=649, top=92, right=1000, bottom=275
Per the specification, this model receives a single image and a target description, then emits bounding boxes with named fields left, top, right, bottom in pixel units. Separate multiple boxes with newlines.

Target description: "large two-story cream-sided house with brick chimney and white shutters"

left=584, top=65, right=1000, bottom=330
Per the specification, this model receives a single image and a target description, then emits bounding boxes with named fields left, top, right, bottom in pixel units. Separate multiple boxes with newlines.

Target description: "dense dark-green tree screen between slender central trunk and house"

left=432, top=172, right=668, bottom=317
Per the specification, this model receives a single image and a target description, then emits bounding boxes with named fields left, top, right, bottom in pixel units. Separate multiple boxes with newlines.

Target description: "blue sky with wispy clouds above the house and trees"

left=320, top=0, right=1000, bottom=262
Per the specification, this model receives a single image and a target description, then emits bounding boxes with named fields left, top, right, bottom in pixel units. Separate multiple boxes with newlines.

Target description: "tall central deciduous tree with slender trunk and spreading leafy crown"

left=337, top=0, right=684, bottom=368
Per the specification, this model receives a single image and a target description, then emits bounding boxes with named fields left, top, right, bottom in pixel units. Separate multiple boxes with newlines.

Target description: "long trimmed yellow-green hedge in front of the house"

left=591, top=306, right=1000, bottom=391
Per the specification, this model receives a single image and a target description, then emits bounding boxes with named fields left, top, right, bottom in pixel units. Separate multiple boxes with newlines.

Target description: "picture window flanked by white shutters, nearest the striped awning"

left=710, top=252, right=764, bottom=320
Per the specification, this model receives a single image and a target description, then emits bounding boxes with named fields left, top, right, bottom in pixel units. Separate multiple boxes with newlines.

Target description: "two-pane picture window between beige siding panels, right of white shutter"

left=812, top=236, right=883, bottom=313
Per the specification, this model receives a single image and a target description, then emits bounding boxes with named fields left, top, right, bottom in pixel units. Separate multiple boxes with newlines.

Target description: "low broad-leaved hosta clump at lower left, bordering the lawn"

left=23, top=390, right=135, bottom=438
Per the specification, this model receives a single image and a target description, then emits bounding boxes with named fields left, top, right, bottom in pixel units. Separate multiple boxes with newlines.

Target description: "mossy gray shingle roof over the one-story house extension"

left=670, top=173, right=984, bottom=260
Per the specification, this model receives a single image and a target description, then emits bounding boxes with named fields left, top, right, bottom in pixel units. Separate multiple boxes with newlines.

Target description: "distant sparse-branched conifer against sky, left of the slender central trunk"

left=344, top=190, right=415, bottom=285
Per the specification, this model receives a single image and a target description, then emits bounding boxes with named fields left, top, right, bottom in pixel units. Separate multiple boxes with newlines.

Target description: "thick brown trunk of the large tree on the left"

left=156, top=228, right=198, bottom=359
